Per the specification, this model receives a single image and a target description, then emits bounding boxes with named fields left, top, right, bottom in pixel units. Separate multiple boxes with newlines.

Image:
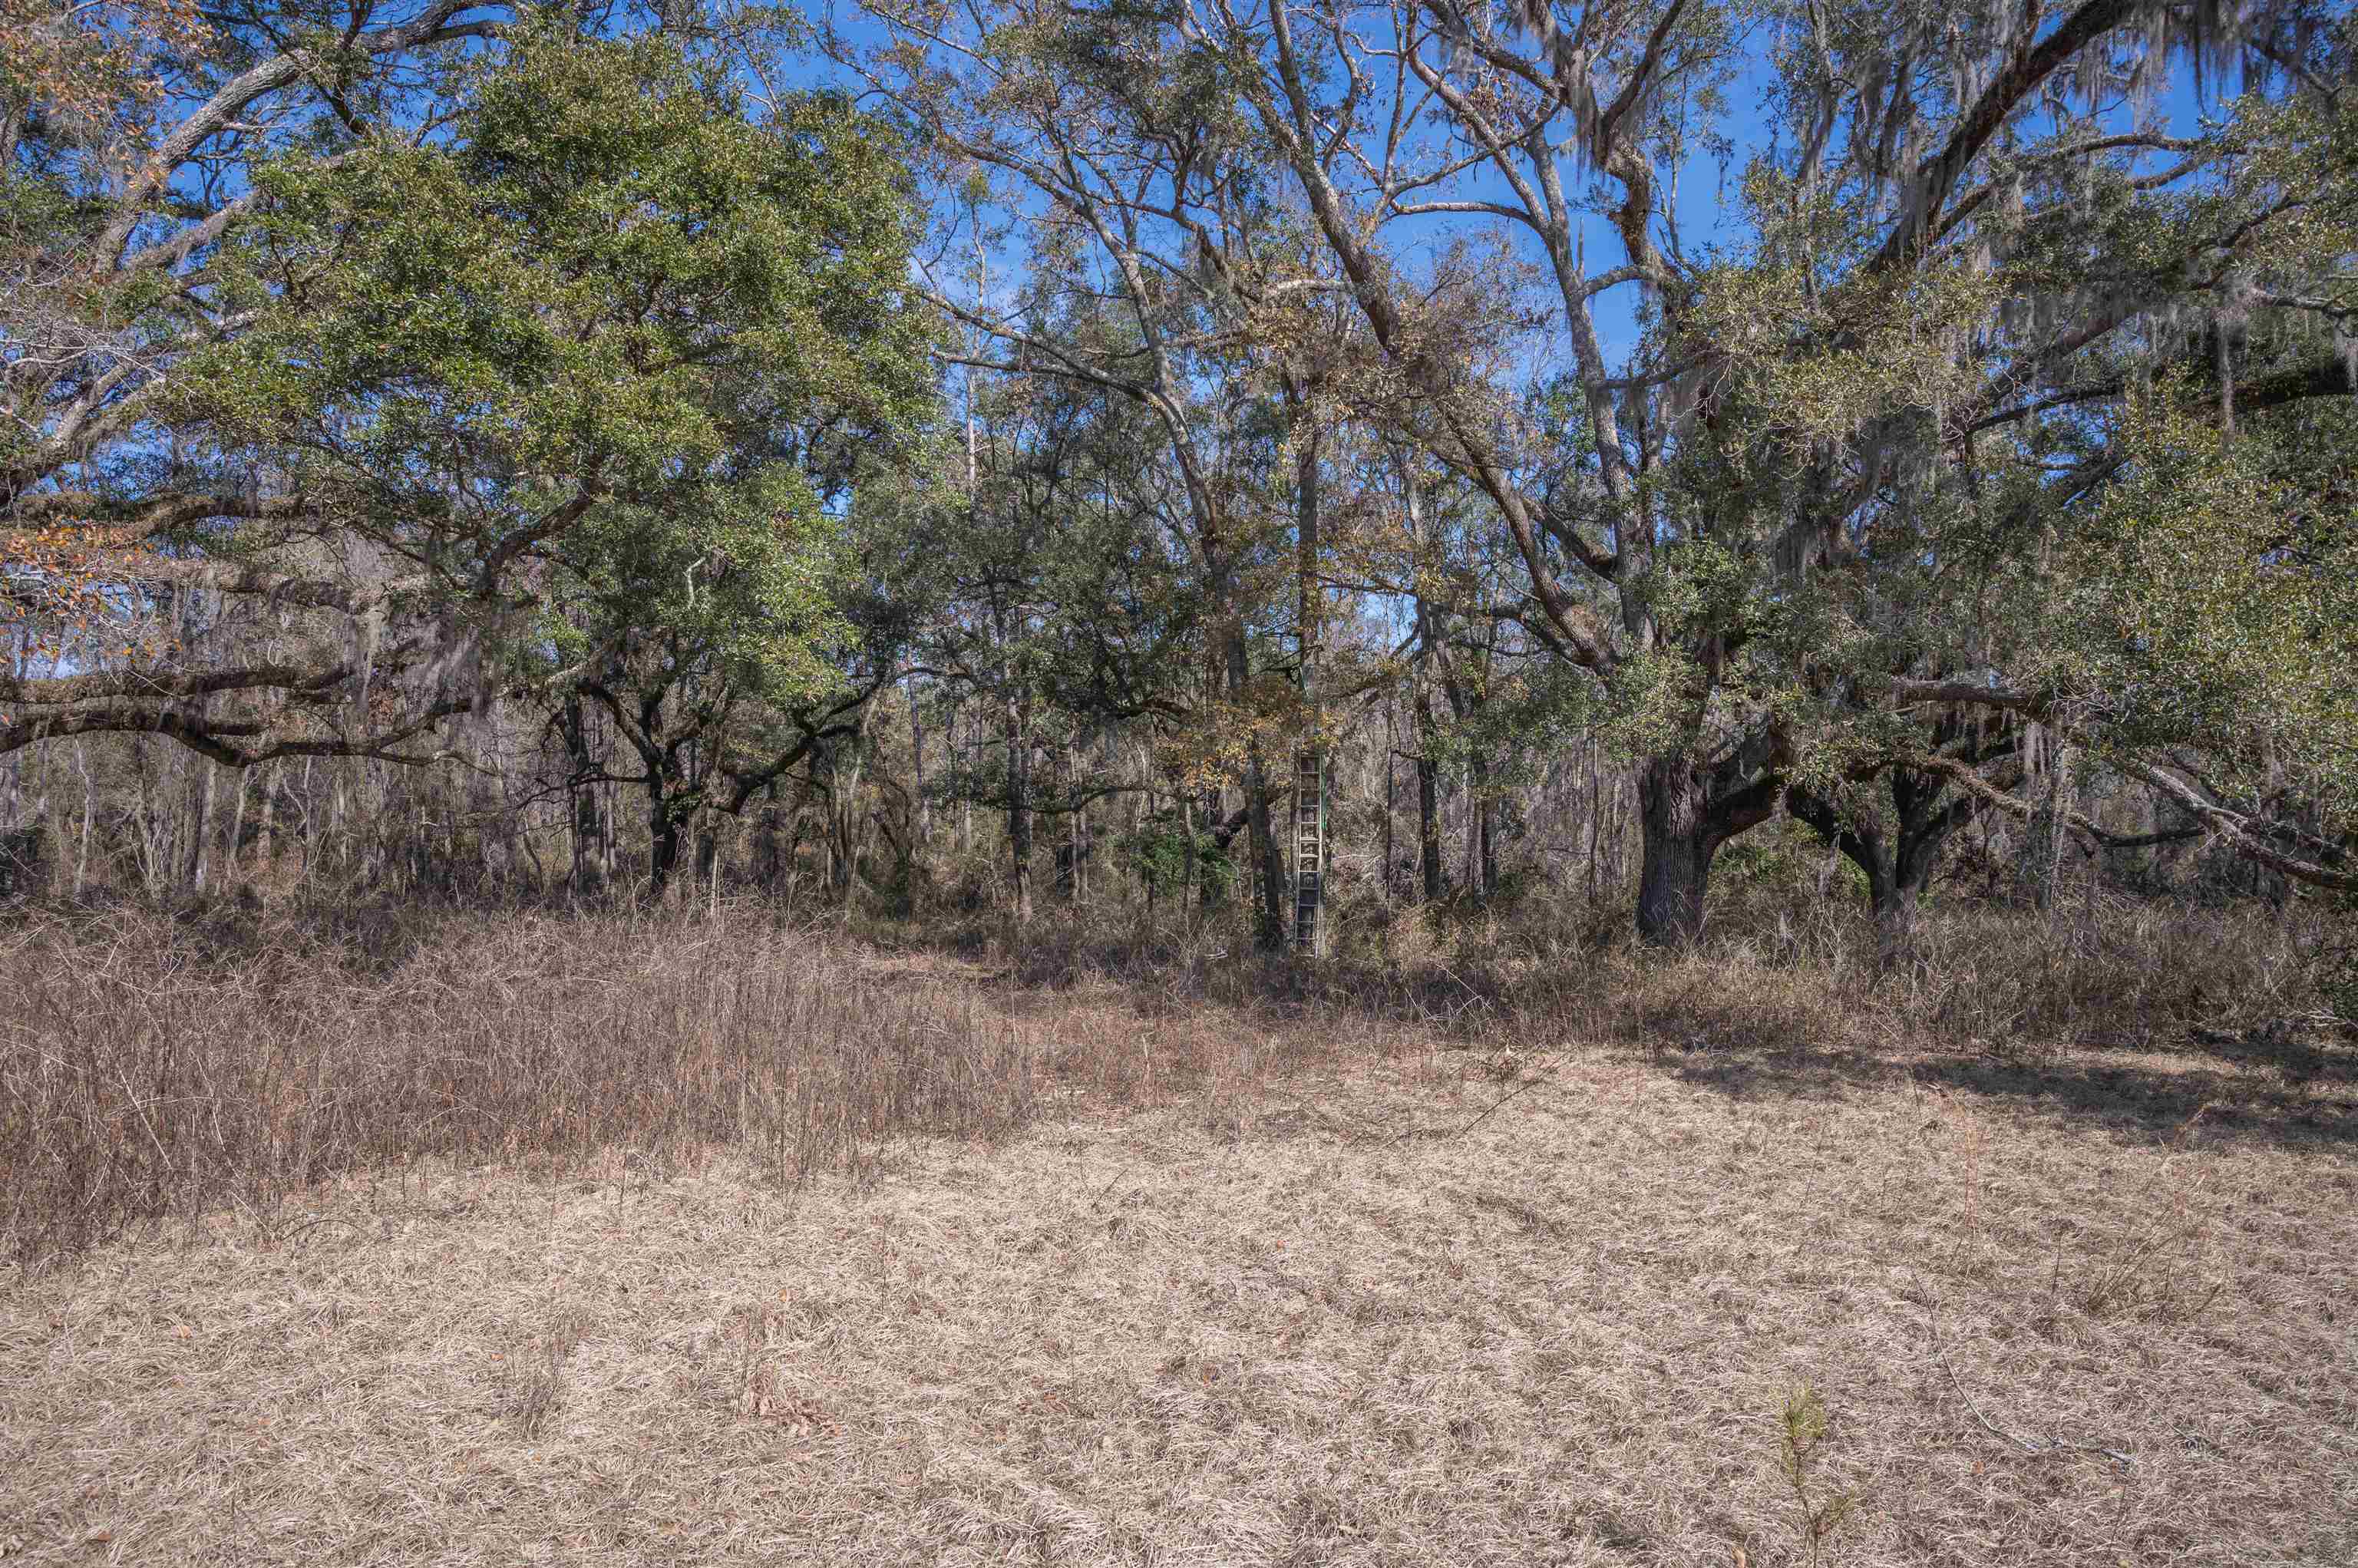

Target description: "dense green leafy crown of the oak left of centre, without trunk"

left=184, top=19, right=929, bottom=695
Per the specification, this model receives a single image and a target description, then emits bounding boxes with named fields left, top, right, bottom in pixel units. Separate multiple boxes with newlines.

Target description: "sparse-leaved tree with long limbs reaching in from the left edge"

left=0, top=0, right=507, bottom=761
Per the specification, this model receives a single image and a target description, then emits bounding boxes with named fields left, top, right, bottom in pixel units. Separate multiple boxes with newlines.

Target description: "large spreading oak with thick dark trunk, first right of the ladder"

left=1197, top=0, right=2351, bottom=941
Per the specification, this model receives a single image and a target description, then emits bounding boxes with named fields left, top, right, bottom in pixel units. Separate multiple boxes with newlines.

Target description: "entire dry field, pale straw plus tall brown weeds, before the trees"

left=0, top=900, right=2358, bottom=1568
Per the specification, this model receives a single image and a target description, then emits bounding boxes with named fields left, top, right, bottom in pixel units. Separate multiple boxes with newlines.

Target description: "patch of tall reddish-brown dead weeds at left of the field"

left=0, top=910, right=1033, bottom=1266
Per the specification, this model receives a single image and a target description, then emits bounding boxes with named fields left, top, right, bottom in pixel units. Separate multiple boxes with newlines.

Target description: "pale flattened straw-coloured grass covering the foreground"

left=0, top=1037, right=2358, bottom=1568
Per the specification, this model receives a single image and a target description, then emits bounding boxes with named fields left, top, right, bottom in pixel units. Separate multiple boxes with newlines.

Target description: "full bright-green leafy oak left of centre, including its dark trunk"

left=372, top=35, right=934, bottom=893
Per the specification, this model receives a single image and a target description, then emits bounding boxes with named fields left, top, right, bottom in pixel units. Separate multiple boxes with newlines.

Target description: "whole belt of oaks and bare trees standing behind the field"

left=0, top=0, right=2358, bottom=983
